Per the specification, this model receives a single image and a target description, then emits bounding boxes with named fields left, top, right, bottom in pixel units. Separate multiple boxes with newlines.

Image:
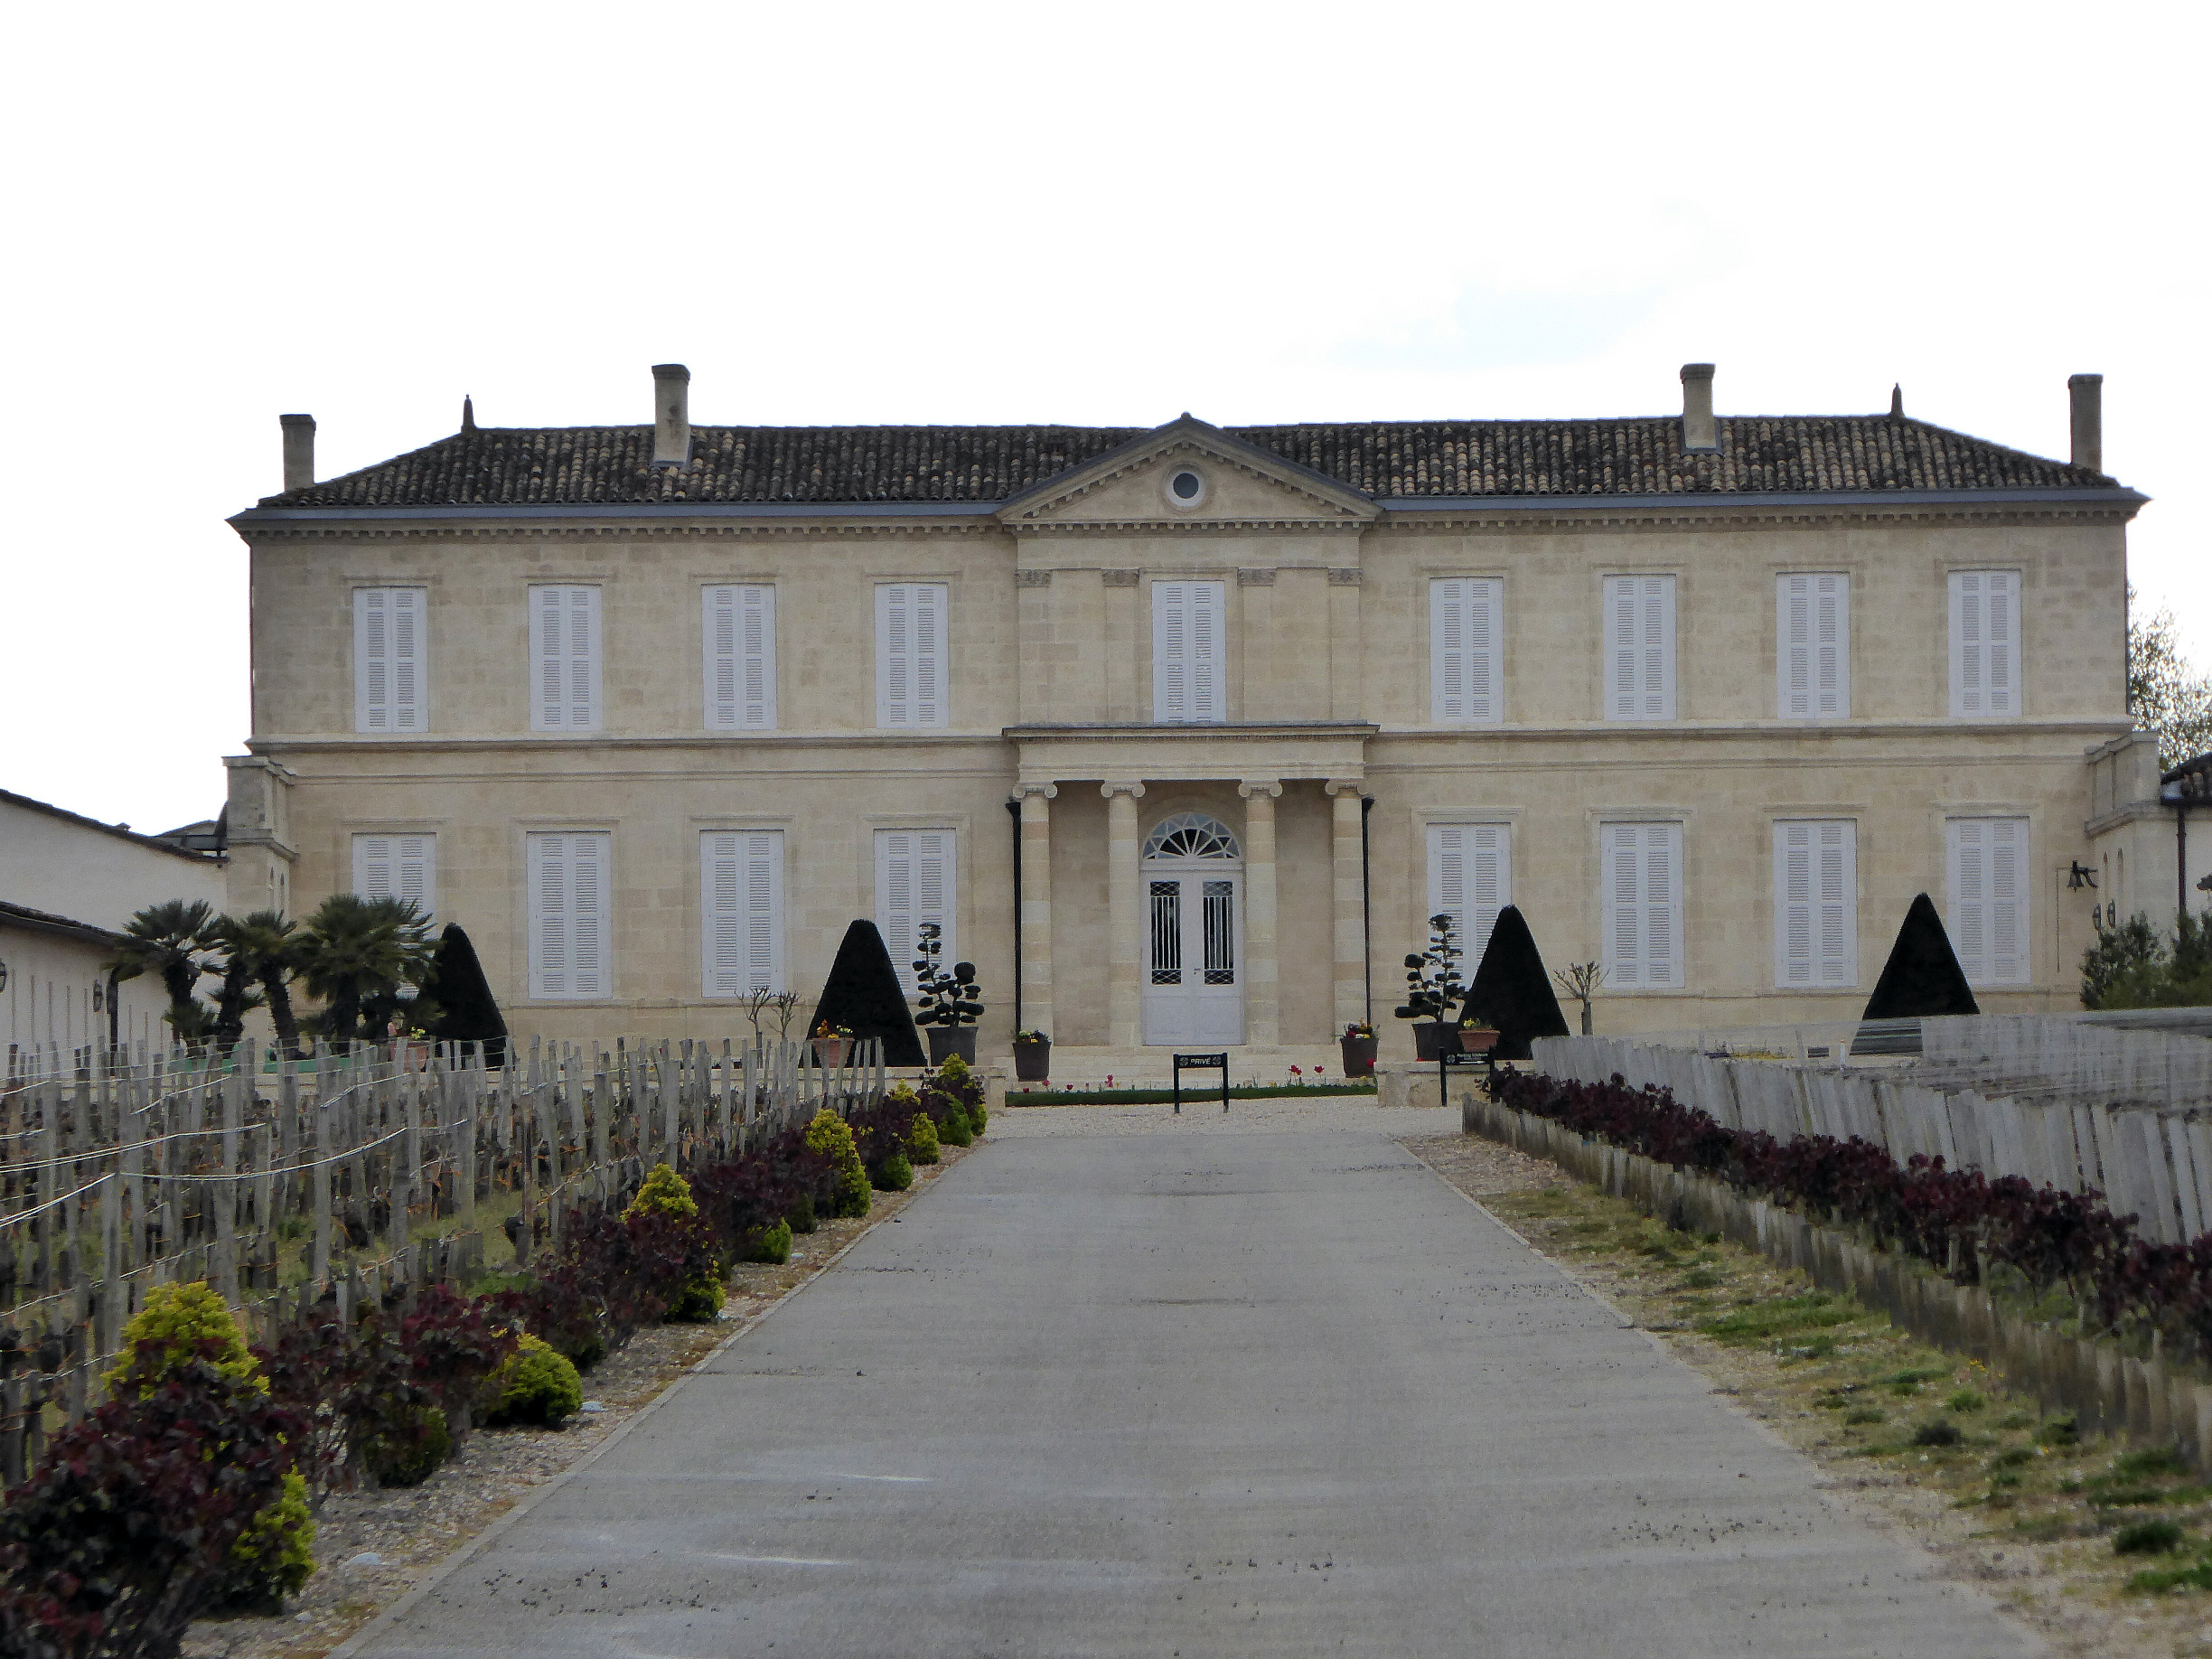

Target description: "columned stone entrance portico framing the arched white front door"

left=1007, top=721, right=1376, bottom=1051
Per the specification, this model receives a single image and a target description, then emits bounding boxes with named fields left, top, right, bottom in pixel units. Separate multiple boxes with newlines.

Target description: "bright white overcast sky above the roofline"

left=0, top=0, right=2212, bottom=830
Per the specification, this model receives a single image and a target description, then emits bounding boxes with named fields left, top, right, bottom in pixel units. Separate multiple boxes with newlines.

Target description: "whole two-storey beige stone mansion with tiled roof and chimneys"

left=228, top=365, right=2159, bottom=1075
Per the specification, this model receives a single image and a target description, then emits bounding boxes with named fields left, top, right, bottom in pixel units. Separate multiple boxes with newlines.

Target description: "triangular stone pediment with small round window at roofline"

left=998, top=414, right=1381, bottom=529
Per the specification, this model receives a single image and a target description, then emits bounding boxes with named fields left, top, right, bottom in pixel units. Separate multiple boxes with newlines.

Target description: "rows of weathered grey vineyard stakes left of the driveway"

left=0, top=1037, right=885, bottom=1485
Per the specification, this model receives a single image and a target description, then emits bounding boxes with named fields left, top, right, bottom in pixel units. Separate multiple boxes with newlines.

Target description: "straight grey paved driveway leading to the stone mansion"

left=371, top=1123, right=2039, bottom=1659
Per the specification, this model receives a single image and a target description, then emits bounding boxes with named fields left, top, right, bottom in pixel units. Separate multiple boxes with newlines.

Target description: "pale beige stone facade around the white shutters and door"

left=230, top=376, right=2150, bottom=1066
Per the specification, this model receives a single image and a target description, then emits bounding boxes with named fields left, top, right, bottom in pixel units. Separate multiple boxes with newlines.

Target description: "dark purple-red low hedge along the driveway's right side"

left=1491, top=1071, right=2212, bottom=1361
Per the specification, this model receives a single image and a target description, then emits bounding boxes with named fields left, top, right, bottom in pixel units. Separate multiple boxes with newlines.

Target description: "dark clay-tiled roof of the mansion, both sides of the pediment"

left=261, top=416, right=2113, bottom=509
